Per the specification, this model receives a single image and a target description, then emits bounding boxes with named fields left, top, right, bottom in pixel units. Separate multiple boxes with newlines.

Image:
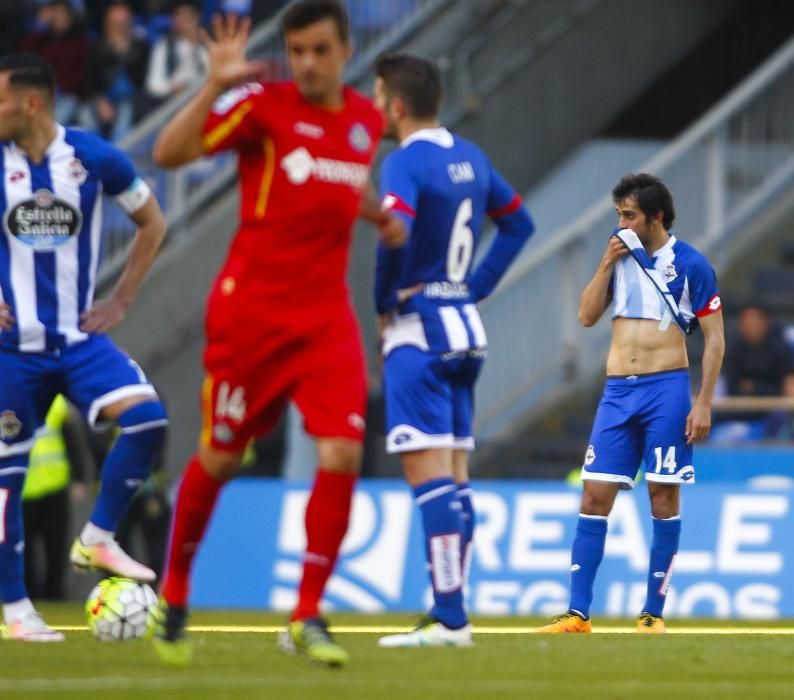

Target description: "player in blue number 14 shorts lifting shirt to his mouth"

left=537, top=174, right=725, bottom=633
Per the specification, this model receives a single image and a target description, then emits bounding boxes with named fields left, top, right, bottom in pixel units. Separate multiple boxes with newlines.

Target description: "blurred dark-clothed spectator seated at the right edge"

left=723, top=303, right=794, bottom=437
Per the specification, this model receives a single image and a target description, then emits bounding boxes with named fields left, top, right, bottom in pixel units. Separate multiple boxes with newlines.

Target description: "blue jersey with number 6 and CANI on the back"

left=375, top=128, right=533, bottom=354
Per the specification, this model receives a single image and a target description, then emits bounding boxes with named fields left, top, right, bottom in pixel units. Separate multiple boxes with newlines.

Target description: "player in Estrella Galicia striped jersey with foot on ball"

left=0, top=54, right=167, bottom=642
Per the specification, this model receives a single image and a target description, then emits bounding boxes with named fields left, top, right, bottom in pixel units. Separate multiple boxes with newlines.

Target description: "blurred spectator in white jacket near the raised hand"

left=146, top=1, right=208, bottom=100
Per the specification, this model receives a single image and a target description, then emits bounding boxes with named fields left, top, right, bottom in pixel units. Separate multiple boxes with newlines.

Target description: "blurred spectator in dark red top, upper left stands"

left=20, top=0, right=91, bottom=124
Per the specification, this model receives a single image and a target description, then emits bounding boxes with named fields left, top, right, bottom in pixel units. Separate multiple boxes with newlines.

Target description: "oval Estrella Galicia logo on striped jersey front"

left=3, top=189, right=83, bottom=250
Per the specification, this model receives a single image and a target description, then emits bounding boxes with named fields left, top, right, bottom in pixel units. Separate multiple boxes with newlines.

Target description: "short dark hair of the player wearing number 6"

left=375, top=53, right=442, bottom=119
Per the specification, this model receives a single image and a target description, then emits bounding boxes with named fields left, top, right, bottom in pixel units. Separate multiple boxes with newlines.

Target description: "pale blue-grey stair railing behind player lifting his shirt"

left=470, top=39, right=794, bottom=438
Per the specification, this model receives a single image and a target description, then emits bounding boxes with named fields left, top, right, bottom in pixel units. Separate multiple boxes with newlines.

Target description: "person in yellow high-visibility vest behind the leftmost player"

left=22, top=395, right=87, bottom=600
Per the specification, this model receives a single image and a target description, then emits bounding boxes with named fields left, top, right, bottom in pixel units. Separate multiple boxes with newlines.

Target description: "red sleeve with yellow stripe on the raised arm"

left=201, top=83, right=265, bottom=154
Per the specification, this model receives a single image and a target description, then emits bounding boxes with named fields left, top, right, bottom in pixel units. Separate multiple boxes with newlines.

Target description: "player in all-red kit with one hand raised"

left=149, top=0, right=402, bottom=666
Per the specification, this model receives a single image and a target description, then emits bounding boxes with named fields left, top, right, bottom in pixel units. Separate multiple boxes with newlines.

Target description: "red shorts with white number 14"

left=201, top=300, right=367, bottom=452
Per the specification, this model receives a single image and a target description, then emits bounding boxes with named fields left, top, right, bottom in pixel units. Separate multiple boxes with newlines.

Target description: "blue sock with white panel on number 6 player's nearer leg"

left=414, top=478, right=468, bottom=629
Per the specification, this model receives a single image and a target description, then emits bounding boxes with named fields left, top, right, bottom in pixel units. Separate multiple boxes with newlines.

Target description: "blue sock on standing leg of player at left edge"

left=0, top=455, right=28, bottom=604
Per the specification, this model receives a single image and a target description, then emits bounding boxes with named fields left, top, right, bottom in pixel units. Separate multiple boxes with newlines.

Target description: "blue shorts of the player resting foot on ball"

left=0, top=335, right=157, bottom=458
